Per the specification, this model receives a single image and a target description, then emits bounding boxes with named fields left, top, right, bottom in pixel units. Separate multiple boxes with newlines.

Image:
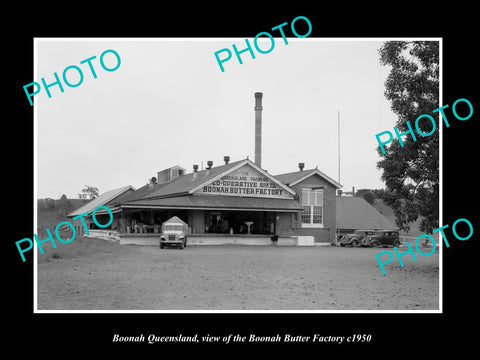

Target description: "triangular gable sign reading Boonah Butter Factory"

left=198, top=165, right=293, bottom=199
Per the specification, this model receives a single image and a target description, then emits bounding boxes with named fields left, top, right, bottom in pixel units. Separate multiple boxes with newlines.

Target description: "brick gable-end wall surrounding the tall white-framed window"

left=291, top=175, right=337, bottom=242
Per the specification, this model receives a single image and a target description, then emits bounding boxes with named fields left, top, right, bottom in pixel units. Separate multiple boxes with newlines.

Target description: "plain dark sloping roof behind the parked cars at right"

left=337, top=196, right=397, bottom=230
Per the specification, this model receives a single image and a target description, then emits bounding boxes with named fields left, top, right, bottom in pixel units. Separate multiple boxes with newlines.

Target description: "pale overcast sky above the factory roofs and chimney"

left=35, top=37, right=397, bottom=199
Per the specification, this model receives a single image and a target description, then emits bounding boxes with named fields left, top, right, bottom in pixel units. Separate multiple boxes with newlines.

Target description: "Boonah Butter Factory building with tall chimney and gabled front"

left=69, top=93, right=341, bottom=245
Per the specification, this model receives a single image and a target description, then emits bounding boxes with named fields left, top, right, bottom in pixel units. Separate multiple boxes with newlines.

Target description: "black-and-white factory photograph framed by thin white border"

left=34, top=37, right=441, bottom=311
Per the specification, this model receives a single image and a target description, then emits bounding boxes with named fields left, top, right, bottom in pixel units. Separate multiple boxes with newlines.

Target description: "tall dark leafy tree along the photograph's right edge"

left=377, top=41, right=440, bottom=233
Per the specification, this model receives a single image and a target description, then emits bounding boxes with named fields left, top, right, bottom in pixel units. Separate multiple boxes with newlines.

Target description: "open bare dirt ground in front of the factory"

left=37, top=238, right=439, bottom=310
